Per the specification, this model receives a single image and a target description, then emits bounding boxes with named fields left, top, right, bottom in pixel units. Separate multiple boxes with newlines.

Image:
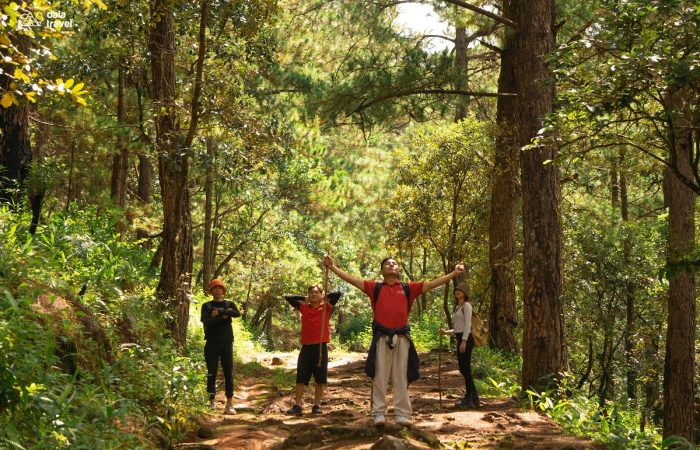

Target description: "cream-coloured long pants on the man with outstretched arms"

left=371, top=335, right=413, bottom=417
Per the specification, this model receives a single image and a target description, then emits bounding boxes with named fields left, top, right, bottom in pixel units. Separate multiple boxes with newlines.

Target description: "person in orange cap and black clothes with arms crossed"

left=201, top=278, right=241, bottom=414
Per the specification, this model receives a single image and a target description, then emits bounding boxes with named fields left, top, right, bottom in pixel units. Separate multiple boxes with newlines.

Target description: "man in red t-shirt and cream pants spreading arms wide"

left=323, top=255, right=464, bottom=426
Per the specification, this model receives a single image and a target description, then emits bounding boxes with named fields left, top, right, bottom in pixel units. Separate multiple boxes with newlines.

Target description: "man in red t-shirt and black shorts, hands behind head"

left=284, top=284, right=341, bottom=414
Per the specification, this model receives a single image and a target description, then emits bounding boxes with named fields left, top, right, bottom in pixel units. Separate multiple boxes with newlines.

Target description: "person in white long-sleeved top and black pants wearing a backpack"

left=440, top=283, right=481, bottom=408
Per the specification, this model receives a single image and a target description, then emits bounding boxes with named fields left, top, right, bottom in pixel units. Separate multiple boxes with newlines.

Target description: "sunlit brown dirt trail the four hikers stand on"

left=186, top=354, right=604, bottom=450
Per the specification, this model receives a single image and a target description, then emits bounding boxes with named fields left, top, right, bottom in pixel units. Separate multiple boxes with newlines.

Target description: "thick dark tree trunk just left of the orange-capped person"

left=149, top=0, right=193, bottom=347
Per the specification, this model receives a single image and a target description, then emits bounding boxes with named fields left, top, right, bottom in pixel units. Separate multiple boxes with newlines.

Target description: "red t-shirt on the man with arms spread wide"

left=364, top=281, right=423, bottom=328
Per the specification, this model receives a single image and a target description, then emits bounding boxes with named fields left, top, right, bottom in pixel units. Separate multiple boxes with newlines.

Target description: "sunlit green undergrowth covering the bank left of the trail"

left=0, top=208, right=206, bottom=449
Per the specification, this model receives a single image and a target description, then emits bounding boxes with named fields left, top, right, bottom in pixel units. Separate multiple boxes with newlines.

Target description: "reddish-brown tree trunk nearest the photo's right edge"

left=663, top=87, right=696, bottom=442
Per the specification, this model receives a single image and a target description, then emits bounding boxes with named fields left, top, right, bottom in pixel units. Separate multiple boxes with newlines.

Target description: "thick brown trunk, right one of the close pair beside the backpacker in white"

left=499, top=0, right=565, bottom=391
